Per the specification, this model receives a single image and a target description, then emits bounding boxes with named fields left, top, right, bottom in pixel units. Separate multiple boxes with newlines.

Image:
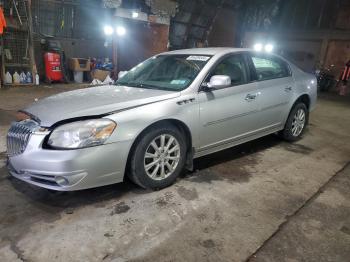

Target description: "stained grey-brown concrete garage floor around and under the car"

left=0, top=87, right=350, bottom=262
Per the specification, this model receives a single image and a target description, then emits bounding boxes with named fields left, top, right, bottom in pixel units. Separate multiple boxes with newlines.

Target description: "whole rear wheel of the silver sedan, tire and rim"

left=281, top=102, right=309, bottom=142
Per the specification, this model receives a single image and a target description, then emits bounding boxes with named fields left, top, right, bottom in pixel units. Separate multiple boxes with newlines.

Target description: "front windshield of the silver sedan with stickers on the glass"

left=116, top=55, right=211, bottom=91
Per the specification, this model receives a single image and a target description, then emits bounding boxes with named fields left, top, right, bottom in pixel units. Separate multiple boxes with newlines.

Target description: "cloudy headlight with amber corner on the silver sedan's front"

left=47, top=118, right=117, bottom=149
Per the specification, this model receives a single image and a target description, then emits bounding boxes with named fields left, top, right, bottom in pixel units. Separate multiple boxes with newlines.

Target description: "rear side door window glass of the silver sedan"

left=252, top=55, right=290, bottom=81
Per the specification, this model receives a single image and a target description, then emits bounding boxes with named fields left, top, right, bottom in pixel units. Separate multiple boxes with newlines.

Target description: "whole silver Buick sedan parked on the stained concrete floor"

left=7, top=48, right=317, bottom=191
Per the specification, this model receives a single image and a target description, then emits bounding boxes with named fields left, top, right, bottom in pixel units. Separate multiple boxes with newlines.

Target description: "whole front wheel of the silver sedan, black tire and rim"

left=128, top=124, right=187, bottom=190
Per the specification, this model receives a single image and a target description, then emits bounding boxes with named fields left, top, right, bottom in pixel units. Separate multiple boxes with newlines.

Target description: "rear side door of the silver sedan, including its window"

left=250, top=53, right=295, bottom=129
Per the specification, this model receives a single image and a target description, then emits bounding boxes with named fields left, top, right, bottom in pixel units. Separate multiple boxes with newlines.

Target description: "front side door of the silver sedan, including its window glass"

left=198, top=54, right=259, bottom=150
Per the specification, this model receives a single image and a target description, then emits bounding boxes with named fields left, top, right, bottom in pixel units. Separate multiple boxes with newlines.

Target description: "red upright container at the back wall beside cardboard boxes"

left=44, top=52, right=63, bottom=83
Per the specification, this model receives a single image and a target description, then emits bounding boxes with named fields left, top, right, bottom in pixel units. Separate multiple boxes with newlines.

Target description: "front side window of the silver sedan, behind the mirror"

left=206, top=55, right=248, bottom=86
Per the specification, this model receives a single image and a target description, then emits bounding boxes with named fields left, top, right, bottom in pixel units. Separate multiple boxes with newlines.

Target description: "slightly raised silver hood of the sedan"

left=23, top=85, right=180, bottom=127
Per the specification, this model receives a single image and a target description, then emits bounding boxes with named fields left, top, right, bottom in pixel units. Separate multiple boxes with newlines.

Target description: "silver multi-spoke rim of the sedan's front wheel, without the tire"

left=144, top=134, right=181, bottom=180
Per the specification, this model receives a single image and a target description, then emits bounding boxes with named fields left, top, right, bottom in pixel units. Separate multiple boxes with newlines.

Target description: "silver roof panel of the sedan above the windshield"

left=162, top=47, right=252, bottom=55
